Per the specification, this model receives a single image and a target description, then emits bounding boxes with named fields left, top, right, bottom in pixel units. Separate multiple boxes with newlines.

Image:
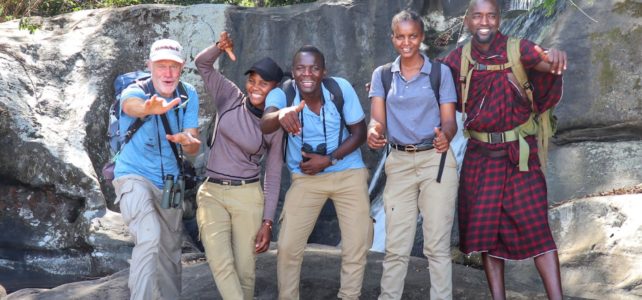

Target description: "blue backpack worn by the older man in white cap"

left=102, top=71, right=188, bottom=182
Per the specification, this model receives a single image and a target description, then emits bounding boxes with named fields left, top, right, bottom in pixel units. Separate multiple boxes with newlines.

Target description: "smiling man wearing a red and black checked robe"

left=444, top=0, right=566, bottom=299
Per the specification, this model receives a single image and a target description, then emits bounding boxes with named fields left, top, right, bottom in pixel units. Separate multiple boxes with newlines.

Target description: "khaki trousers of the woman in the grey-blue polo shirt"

left=379, top=149, right=458, bottom=300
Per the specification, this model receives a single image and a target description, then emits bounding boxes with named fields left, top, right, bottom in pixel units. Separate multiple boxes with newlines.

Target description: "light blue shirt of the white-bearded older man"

left=114, top=83, right=198, bottom=188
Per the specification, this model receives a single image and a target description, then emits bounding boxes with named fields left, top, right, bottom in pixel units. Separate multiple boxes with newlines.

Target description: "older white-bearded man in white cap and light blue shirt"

left=113, top=39, right=200, bottom=299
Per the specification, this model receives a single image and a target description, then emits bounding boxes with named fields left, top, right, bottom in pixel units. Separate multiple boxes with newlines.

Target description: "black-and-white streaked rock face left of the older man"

left=0, top=5, right=226, bottom=289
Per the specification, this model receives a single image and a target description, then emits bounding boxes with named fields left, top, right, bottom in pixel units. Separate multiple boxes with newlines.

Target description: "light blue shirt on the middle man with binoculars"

left=265, top=77, right=365, bottom=174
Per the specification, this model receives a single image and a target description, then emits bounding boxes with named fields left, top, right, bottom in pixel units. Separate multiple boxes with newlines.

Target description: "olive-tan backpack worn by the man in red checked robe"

left=459, top=37, right=557, bottom=173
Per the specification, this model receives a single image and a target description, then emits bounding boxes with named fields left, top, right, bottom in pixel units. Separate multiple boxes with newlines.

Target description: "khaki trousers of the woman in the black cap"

left=196, top=182, right=263, bottom=300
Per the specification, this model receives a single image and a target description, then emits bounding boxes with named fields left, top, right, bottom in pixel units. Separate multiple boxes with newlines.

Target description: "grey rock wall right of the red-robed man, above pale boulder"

left=502, top=0, right=642, bottom=202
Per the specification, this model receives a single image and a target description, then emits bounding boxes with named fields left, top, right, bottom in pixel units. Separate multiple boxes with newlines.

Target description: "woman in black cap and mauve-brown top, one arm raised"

left=195, top=32, right=283, bottom=299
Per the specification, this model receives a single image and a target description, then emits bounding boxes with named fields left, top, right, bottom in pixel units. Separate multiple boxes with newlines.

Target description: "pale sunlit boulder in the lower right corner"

left=506, top=193, right=642, bottom=299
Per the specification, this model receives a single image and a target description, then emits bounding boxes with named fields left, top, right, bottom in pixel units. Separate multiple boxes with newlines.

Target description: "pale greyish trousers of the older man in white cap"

left=113, top=175, right=183, bottom=300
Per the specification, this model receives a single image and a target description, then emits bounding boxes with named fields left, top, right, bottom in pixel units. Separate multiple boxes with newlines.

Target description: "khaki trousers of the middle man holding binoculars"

left=277, top=168, right=372, bottom=299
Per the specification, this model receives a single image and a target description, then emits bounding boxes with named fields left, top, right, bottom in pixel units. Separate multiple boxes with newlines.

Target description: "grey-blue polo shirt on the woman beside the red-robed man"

left=369, top=54, right=457, bottom=145
